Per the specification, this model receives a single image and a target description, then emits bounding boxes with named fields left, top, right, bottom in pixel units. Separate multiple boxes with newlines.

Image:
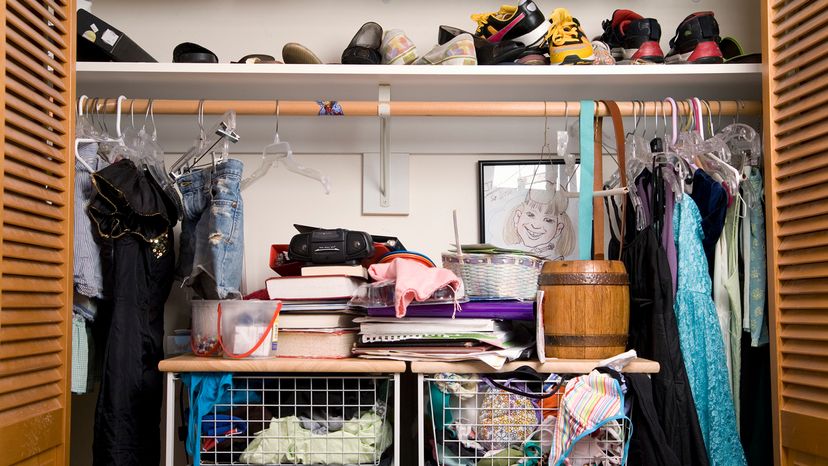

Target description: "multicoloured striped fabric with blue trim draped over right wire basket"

left=549, top=371, right=629, bottom=466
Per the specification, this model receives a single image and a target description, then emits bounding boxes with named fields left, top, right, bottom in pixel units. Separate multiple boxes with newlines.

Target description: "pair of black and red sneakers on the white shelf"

left=600, top=10, right=723, bottom=63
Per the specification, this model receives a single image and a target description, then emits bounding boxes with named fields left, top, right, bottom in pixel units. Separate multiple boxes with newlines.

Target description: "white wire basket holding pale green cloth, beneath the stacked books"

left=199, top=374, right=394, bottom=466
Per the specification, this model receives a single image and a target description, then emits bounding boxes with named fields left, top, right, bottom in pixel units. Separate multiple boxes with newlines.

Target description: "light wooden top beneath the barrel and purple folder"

left=411, top=358, right=660, bottom=374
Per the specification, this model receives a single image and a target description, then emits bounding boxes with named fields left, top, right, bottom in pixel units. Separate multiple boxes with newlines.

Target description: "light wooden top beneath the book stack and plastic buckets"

left=158, top=354, right=406, bottom=374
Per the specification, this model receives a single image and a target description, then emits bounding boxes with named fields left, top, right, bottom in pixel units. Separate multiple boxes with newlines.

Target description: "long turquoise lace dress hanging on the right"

left=673, top=196, right=746, bottom=466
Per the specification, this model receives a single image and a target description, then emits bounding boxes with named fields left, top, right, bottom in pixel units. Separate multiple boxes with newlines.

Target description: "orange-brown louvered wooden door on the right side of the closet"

left=763, top=0, right=828, bottom=465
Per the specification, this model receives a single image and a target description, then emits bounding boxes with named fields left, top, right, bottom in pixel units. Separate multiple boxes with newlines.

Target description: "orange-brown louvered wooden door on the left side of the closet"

left=0, top=0, right=75, bottom=465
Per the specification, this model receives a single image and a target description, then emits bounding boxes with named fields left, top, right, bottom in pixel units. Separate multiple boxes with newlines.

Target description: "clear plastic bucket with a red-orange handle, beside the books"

left=218, top=300, right=282, bottom=359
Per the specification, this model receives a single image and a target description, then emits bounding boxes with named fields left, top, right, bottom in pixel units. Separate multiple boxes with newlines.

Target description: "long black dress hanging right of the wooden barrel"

left=610, top=172, right=709, bottom=466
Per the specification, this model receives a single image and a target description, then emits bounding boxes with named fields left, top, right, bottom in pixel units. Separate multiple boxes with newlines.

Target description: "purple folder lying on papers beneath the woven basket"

left=368, top=301, right=535, bottom=320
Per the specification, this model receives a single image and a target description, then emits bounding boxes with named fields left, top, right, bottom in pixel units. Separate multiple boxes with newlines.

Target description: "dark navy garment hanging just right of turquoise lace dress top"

left=690, top=170, right=730, bottom=278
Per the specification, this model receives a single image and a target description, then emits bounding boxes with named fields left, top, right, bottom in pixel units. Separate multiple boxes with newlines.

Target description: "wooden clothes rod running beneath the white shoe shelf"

left=94, top=98, right=762, bottom=117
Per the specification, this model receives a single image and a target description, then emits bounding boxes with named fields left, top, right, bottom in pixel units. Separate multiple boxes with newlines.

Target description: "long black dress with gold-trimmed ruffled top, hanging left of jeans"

left=89, top=160, right=178, bottom=466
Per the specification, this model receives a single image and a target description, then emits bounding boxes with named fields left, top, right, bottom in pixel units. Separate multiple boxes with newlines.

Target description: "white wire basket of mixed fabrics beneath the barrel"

left=423, top=374, right=631, bottom=466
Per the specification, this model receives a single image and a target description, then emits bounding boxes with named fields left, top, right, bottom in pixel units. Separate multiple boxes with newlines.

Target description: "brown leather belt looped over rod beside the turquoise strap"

left=592, top=100, right=627, bottom=260
